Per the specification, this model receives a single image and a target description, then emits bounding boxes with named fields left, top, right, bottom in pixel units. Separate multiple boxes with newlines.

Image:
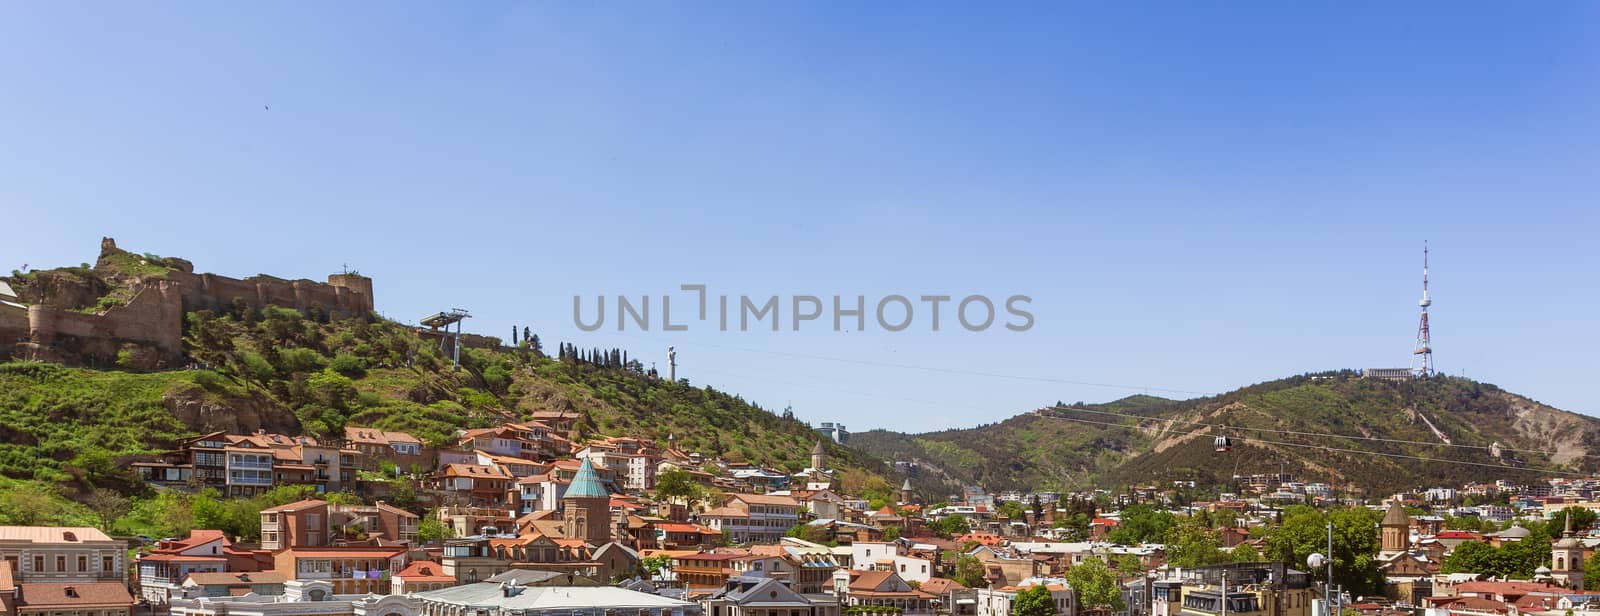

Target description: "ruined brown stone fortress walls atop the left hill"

left=0, top=237, right=373, bottom=370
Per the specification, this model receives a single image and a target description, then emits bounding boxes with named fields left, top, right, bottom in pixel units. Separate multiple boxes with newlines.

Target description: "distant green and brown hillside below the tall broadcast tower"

left=851, top=373, right=1600, bottom=494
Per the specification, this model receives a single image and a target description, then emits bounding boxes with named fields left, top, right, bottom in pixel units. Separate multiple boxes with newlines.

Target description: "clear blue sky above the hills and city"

left=0, top=2, right=1600, bottom=430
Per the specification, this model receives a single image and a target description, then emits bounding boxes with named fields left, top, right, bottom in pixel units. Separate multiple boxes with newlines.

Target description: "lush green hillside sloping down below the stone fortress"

left=0, top=244, right=885, bottom=508
